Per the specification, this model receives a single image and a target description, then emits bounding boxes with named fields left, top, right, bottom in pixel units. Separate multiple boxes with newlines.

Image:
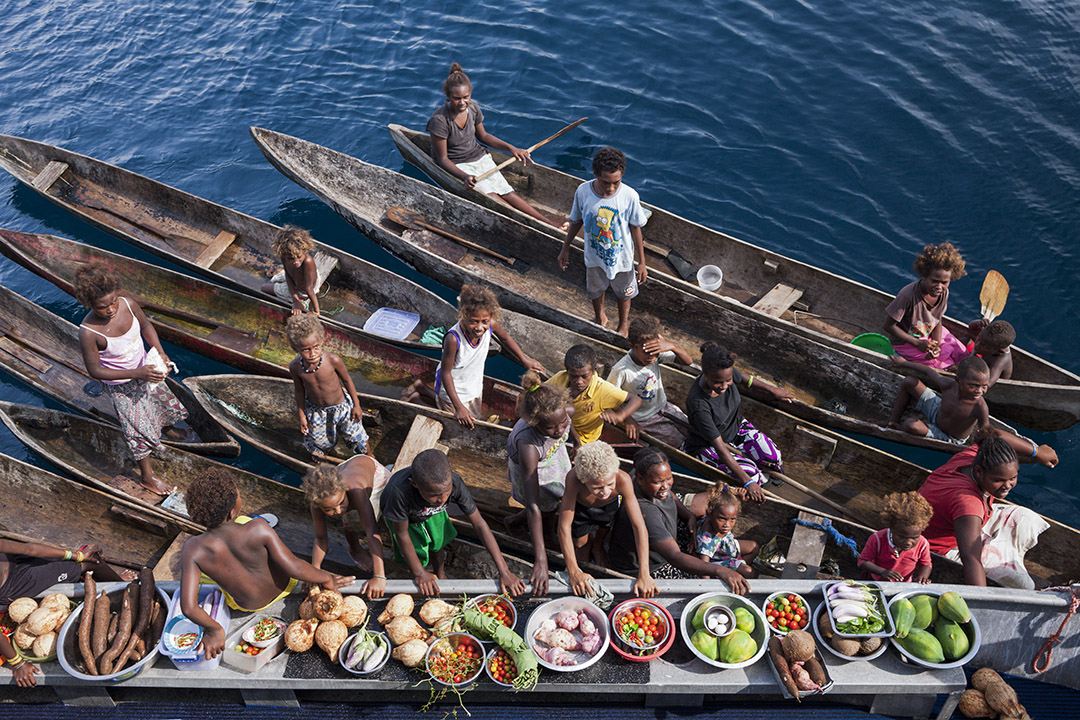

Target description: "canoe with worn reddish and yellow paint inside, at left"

left=0, top=230, right=516, bottom=418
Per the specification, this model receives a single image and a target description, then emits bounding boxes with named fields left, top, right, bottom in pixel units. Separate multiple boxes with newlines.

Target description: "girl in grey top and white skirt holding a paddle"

left=427, top=63, right=558, bottom=227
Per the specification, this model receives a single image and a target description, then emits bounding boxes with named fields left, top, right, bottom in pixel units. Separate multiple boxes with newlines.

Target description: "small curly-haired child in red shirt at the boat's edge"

left=859, top=490, right=934, bottom=584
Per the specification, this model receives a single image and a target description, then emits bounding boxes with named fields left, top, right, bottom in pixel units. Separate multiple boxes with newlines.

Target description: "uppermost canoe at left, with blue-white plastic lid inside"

left=0, top=135, right=457, bottom=349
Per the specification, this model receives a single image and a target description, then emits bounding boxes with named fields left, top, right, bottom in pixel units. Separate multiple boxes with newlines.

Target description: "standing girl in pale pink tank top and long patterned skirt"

left=75, top=263, right=188, bottom=495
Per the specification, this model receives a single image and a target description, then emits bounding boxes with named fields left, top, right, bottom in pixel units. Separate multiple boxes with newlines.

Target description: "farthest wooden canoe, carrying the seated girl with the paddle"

left=388, top=124, right=1080, bottom=431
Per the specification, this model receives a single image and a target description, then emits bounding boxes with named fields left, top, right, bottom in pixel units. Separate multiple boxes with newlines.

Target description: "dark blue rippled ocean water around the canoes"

left=0, top=0, right=1080, bottom=524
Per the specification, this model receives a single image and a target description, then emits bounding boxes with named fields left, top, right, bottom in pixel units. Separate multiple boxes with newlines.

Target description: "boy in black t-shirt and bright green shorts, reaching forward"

left=380, top=449, right=525, bottom=597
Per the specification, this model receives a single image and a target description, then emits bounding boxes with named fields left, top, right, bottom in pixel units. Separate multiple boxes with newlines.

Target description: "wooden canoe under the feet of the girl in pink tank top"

left=0, top=402, right=353, bottom=567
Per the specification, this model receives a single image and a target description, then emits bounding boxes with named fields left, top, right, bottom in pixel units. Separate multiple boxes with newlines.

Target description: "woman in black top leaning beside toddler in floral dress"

left=608, top=448, right=750, bottom=595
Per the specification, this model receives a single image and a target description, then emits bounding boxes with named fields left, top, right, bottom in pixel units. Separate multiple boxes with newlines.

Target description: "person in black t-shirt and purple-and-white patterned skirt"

left=681, top=342, right=793, bottom=502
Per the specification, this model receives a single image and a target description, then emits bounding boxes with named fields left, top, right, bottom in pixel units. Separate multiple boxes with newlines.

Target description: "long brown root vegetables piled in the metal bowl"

left=77, top=568, right=166, bottom=676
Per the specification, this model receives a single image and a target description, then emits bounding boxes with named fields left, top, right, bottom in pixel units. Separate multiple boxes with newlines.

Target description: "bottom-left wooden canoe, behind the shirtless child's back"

left=0, top=454, right=189, bottom=580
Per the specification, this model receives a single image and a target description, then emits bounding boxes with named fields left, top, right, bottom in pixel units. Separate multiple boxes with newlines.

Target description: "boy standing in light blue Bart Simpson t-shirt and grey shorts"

left=558, top=147, right=649, bottom=337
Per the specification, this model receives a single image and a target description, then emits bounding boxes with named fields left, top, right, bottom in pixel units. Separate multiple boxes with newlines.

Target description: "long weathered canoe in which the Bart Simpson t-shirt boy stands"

left=251, top=122, right=1019, bottom=451
